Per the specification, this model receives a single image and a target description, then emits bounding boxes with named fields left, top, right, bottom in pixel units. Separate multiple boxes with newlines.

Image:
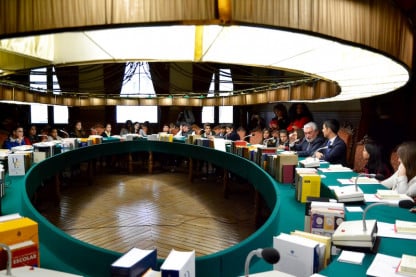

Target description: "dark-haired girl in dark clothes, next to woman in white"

left=362, top=142, right=393, bottom=181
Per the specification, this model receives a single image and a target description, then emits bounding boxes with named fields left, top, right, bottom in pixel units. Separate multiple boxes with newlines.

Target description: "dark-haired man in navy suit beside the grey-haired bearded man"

left=315, top=119, right=347, bottom=166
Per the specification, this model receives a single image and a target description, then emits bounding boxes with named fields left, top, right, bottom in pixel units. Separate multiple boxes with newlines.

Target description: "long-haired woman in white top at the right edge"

left=381, top=141, right=416, bottom=197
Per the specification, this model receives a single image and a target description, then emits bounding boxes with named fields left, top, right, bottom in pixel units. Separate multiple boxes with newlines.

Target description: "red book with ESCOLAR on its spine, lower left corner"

left=0, top=240, right=39, bottom=270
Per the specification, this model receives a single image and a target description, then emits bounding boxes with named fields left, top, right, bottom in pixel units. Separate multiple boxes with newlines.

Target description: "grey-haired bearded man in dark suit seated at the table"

left=290, top=122, right=325, bottom=157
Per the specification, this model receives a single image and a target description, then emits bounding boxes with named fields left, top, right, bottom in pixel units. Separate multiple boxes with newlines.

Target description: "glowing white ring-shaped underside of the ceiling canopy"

left=0, top=25, right=410, bottom=102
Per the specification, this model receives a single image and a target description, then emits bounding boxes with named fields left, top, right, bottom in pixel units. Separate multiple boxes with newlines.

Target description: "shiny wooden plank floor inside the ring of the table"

left=38, top=164, right=256, bottom=258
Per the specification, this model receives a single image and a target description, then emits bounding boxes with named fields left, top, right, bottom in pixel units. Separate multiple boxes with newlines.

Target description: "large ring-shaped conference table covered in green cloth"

left=2, top=140, right=416, bottom=277
